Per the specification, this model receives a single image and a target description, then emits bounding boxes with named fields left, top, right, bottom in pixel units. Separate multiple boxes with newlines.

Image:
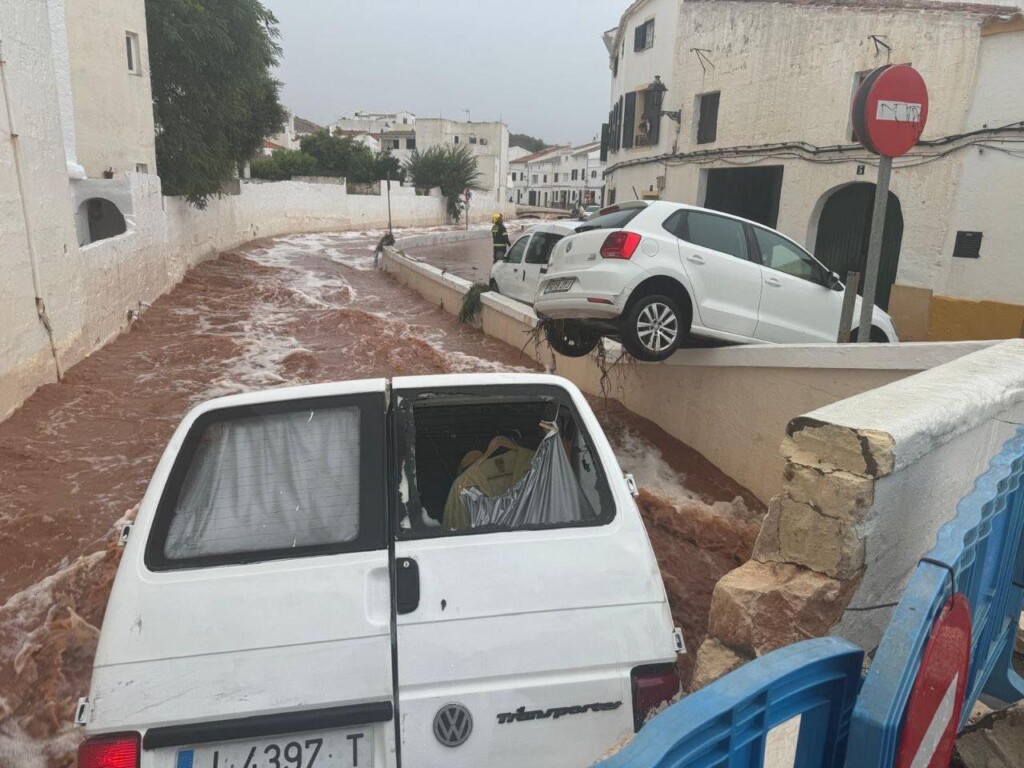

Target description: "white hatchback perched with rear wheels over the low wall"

left=535, top=201, right=897, bottom=360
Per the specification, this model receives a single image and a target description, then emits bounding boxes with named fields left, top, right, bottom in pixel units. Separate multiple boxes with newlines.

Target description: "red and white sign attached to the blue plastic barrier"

left=895, top=595, right=971, bottom=768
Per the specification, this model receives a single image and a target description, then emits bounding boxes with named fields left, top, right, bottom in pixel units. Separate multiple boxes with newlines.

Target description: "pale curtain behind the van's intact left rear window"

left=164, top=408, right=359, bottom=560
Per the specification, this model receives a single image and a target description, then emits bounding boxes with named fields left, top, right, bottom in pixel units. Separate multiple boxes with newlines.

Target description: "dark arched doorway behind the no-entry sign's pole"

left=814, top=182, right=903, bottom=309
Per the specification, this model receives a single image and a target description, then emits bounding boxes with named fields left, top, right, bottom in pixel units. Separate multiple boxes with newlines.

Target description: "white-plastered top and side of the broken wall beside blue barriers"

left=805, top=340, right=1024, bottom=649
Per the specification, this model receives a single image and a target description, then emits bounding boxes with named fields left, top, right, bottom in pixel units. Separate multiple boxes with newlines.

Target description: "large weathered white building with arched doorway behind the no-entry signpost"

left=604, top=0, right=1024, bottom=339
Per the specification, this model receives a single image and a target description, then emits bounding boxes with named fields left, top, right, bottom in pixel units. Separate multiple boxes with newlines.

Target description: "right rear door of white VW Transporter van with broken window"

left=385, top=376, right=675, bottom=768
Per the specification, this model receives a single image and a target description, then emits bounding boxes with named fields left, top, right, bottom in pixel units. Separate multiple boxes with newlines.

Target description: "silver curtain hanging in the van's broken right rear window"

left=460, top=430, right=595, bottom=528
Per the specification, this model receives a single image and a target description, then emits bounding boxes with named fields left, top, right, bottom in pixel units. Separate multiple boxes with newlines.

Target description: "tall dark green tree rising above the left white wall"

left=145, top=0, right=287, bottom=208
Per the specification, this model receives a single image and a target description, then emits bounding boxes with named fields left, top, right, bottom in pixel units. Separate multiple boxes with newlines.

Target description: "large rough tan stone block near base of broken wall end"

left=698, top=560, right=860, bottom=662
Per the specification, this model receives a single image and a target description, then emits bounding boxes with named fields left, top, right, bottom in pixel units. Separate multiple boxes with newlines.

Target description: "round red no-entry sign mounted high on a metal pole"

left=853, top=65, right=928, bottom=158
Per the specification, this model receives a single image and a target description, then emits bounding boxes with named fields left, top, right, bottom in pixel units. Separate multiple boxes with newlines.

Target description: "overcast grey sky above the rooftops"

left=263, top=0, right=630, bottom=143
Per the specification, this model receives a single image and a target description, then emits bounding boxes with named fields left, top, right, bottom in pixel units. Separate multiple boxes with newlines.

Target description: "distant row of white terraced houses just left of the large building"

left=509, top=141, right=604, bottom=209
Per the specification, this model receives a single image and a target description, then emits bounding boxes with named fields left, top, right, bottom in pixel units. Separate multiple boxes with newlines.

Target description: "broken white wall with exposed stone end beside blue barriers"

left=695, top=340, right=1024, bottom=685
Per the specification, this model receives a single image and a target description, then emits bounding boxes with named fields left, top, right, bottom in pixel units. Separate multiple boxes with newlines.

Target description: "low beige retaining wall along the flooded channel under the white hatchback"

left=384, top=243, right=993, bottom=502
